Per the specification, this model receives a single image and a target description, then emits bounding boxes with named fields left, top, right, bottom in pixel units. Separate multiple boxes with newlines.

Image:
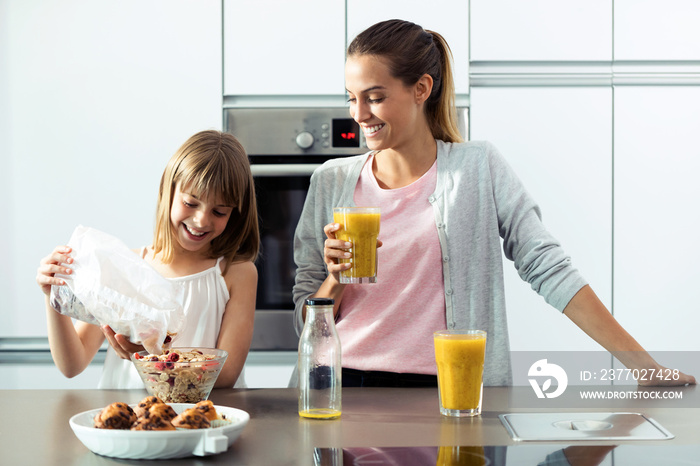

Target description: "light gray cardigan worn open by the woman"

left=293, top=140, right=586, bottom=386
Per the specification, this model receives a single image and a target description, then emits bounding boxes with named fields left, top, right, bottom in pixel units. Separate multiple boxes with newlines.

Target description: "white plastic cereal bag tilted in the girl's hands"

left=51, top=225, right=185, bottom=354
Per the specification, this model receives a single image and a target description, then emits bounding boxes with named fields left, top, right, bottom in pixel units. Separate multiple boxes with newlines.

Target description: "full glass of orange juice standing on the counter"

left=433, top=330, right=486, bottom=417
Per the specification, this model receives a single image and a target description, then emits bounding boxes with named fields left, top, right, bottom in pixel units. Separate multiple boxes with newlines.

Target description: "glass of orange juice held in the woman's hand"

left=333, top=207, right=380, bottom=283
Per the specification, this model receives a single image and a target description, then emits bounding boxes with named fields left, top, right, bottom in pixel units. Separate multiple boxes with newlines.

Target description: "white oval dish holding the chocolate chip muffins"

left=69, top=403, right=250, bottom=459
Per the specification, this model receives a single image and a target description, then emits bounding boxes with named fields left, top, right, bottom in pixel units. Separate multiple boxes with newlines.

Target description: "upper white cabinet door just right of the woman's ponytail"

left=470, top=0, right=613, bottom=61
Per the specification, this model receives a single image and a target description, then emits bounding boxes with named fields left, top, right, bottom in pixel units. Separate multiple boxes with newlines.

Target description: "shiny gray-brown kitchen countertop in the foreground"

left=0, top=386, right=700, bottom=466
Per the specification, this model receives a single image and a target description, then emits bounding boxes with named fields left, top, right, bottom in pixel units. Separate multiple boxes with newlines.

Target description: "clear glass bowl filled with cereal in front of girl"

left=131, top=348, right=228, bottom=403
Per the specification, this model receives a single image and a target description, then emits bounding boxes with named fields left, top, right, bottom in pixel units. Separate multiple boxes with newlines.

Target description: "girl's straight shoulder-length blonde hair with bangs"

left=153, top=130, right=260, bottom=274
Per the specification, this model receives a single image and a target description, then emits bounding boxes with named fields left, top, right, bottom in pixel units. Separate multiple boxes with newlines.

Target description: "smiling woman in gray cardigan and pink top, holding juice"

left=294, top=20, right=695, bottom=386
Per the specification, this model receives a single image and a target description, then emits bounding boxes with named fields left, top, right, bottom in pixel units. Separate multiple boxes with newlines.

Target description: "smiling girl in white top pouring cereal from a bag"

left=37, top=131, right=260, bottom=388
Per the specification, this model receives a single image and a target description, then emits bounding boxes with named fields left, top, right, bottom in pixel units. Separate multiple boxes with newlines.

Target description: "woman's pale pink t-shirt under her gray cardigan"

left=337, top=156, right=446, bottom=374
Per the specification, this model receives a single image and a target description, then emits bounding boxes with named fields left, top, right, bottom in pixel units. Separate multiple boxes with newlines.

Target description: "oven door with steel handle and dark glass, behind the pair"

left=251, top=163, right=319, bottom=351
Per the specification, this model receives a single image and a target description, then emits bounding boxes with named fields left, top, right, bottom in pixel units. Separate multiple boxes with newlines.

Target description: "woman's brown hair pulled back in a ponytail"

left=348, top=19, right=463, bottom=142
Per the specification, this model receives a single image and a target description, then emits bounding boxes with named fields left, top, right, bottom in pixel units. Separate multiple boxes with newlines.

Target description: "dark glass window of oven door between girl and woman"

left=250, top=176, right=310, bottom=310
